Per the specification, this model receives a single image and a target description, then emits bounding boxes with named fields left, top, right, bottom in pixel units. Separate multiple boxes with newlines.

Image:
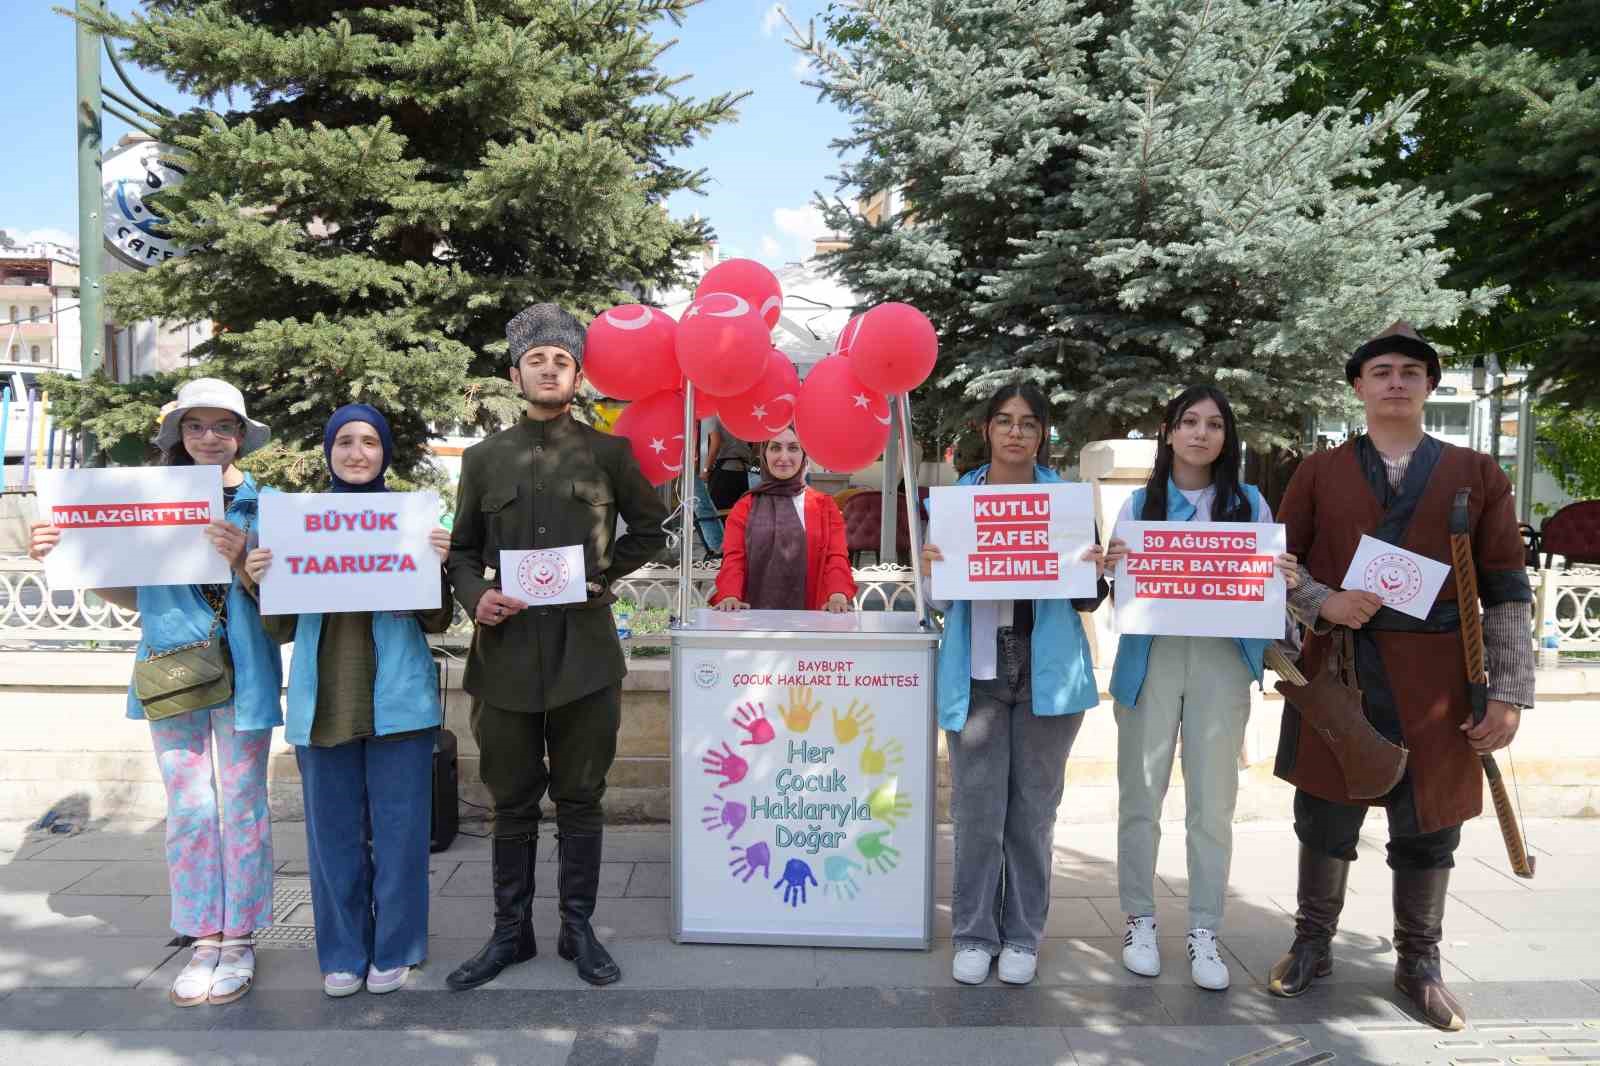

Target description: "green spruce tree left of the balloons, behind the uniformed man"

left=62, top=0, right=739, bottom=485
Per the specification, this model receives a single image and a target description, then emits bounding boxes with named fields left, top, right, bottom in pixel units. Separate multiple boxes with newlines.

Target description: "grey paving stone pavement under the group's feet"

left=0, top=816, right=1600, bottom=1066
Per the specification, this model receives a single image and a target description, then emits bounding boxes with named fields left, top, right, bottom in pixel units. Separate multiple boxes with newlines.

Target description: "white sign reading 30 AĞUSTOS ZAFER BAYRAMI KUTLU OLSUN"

left=1117, top=522, right=1286, bottom=640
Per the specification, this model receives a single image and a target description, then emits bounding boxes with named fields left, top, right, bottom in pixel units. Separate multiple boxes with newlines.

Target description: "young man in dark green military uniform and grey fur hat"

left=446, top=304, right=667, bottom=989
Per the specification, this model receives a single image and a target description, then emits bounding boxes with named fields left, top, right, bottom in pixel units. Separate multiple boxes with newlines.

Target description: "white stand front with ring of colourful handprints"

left=674, top=611, right=934, bottom=948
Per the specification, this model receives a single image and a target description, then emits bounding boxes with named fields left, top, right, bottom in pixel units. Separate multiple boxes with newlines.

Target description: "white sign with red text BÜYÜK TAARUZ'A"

left=261, top=490, right=442, bottom=615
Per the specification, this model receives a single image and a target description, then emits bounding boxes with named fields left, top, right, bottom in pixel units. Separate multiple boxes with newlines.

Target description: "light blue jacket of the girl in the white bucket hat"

left=128, top=474, right=283, bottom=730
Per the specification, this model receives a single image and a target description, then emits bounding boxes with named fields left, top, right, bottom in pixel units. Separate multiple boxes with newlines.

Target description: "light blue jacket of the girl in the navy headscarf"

left=283, top=601, right=443, bottom=746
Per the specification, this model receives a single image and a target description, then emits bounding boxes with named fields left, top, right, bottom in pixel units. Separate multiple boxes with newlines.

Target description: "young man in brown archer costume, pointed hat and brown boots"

left=1269, top=322, right=1533, bottom=1029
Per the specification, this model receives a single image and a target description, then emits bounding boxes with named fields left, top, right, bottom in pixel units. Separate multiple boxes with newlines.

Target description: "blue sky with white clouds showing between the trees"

left=0, top=0, right=846, bottom=266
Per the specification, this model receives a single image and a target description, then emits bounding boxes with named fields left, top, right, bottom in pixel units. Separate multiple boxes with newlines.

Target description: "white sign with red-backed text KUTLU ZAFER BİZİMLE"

left=928, top=482, right=1096, bottom=600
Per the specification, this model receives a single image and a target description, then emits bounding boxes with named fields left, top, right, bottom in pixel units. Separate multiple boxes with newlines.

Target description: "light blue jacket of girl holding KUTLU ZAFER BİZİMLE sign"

left=934, top=464, right=1099, bottom=731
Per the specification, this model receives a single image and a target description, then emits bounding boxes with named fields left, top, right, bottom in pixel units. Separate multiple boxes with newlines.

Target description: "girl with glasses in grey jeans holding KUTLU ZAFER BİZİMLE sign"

left=922, top=384, right=1106, bottom=984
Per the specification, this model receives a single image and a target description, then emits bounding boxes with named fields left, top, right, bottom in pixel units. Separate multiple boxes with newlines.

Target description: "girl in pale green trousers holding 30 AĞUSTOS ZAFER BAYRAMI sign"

left=1106, top=384, right=1296, bottom=991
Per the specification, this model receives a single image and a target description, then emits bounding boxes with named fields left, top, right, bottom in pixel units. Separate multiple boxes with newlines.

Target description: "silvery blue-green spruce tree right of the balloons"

left=797, top=0, right=1493, bottom=443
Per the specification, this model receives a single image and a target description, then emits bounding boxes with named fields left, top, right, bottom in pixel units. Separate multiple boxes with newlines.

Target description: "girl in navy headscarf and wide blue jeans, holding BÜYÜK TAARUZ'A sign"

left=246, top=403, right=454, bottom=997
